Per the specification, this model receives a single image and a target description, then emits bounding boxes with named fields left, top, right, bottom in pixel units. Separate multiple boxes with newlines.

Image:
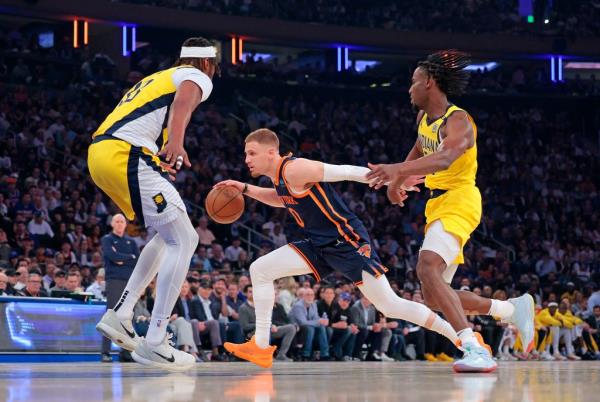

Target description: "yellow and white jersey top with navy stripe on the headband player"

left=92, top=66, right=213, bottom=154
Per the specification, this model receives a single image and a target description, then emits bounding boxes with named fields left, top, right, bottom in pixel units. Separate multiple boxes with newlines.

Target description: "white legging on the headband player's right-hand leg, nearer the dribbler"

left=146, top=211, right=198, bottom=345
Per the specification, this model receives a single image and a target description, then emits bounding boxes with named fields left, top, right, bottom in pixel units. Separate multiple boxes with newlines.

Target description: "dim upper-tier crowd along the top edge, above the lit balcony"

left=117, top=0, right=600, bottom=37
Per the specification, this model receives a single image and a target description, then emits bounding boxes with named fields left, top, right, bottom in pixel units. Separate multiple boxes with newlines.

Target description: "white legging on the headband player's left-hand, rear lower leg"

left=114, top=233, right=167, bottom=320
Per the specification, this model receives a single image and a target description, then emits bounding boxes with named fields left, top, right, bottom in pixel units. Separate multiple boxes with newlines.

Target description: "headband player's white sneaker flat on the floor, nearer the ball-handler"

left=131, top=336, right=196, bottom=371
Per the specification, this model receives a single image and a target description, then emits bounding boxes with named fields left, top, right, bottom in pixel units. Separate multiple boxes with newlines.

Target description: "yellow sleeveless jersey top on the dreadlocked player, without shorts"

left=418, top=105, right=477, bottom=190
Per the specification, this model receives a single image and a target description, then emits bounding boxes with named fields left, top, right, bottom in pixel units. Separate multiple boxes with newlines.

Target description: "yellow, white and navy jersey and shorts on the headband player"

left=88, top=66, right=212, bottom=227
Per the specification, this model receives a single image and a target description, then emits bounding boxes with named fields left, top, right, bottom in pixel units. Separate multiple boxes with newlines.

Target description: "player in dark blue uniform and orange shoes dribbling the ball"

left=215, top=129, right=458, bottom=367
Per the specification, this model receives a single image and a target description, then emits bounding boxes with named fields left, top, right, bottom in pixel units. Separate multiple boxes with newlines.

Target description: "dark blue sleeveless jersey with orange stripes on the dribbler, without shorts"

left=274, top=157, right=370, bottom=248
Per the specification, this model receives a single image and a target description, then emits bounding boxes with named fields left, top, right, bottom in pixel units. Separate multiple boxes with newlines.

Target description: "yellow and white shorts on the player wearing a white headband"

left=88, top=135, right=186, bottom=226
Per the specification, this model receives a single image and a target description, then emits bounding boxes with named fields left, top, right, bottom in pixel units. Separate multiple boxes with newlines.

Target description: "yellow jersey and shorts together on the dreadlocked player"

left=417, top=105, right=482, bottom=264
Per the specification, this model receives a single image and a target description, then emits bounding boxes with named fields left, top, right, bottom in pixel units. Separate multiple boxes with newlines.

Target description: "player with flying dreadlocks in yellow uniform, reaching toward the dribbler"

left=367, top=50, right=535, bottom=372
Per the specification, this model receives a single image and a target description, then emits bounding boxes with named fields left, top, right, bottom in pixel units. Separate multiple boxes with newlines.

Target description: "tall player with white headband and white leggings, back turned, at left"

left=88, top=38, right=218, bottom=370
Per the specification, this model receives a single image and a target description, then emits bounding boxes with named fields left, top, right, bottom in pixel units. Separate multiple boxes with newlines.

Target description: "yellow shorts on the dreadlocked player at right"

left=425, top=186, right=482, bottom=264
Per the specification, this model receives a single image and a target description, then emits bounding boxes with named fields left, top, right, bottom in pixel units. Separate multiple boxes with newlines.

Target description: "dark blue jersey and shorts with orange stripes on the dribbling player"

left=273, top=157, right=388, bottom=286
